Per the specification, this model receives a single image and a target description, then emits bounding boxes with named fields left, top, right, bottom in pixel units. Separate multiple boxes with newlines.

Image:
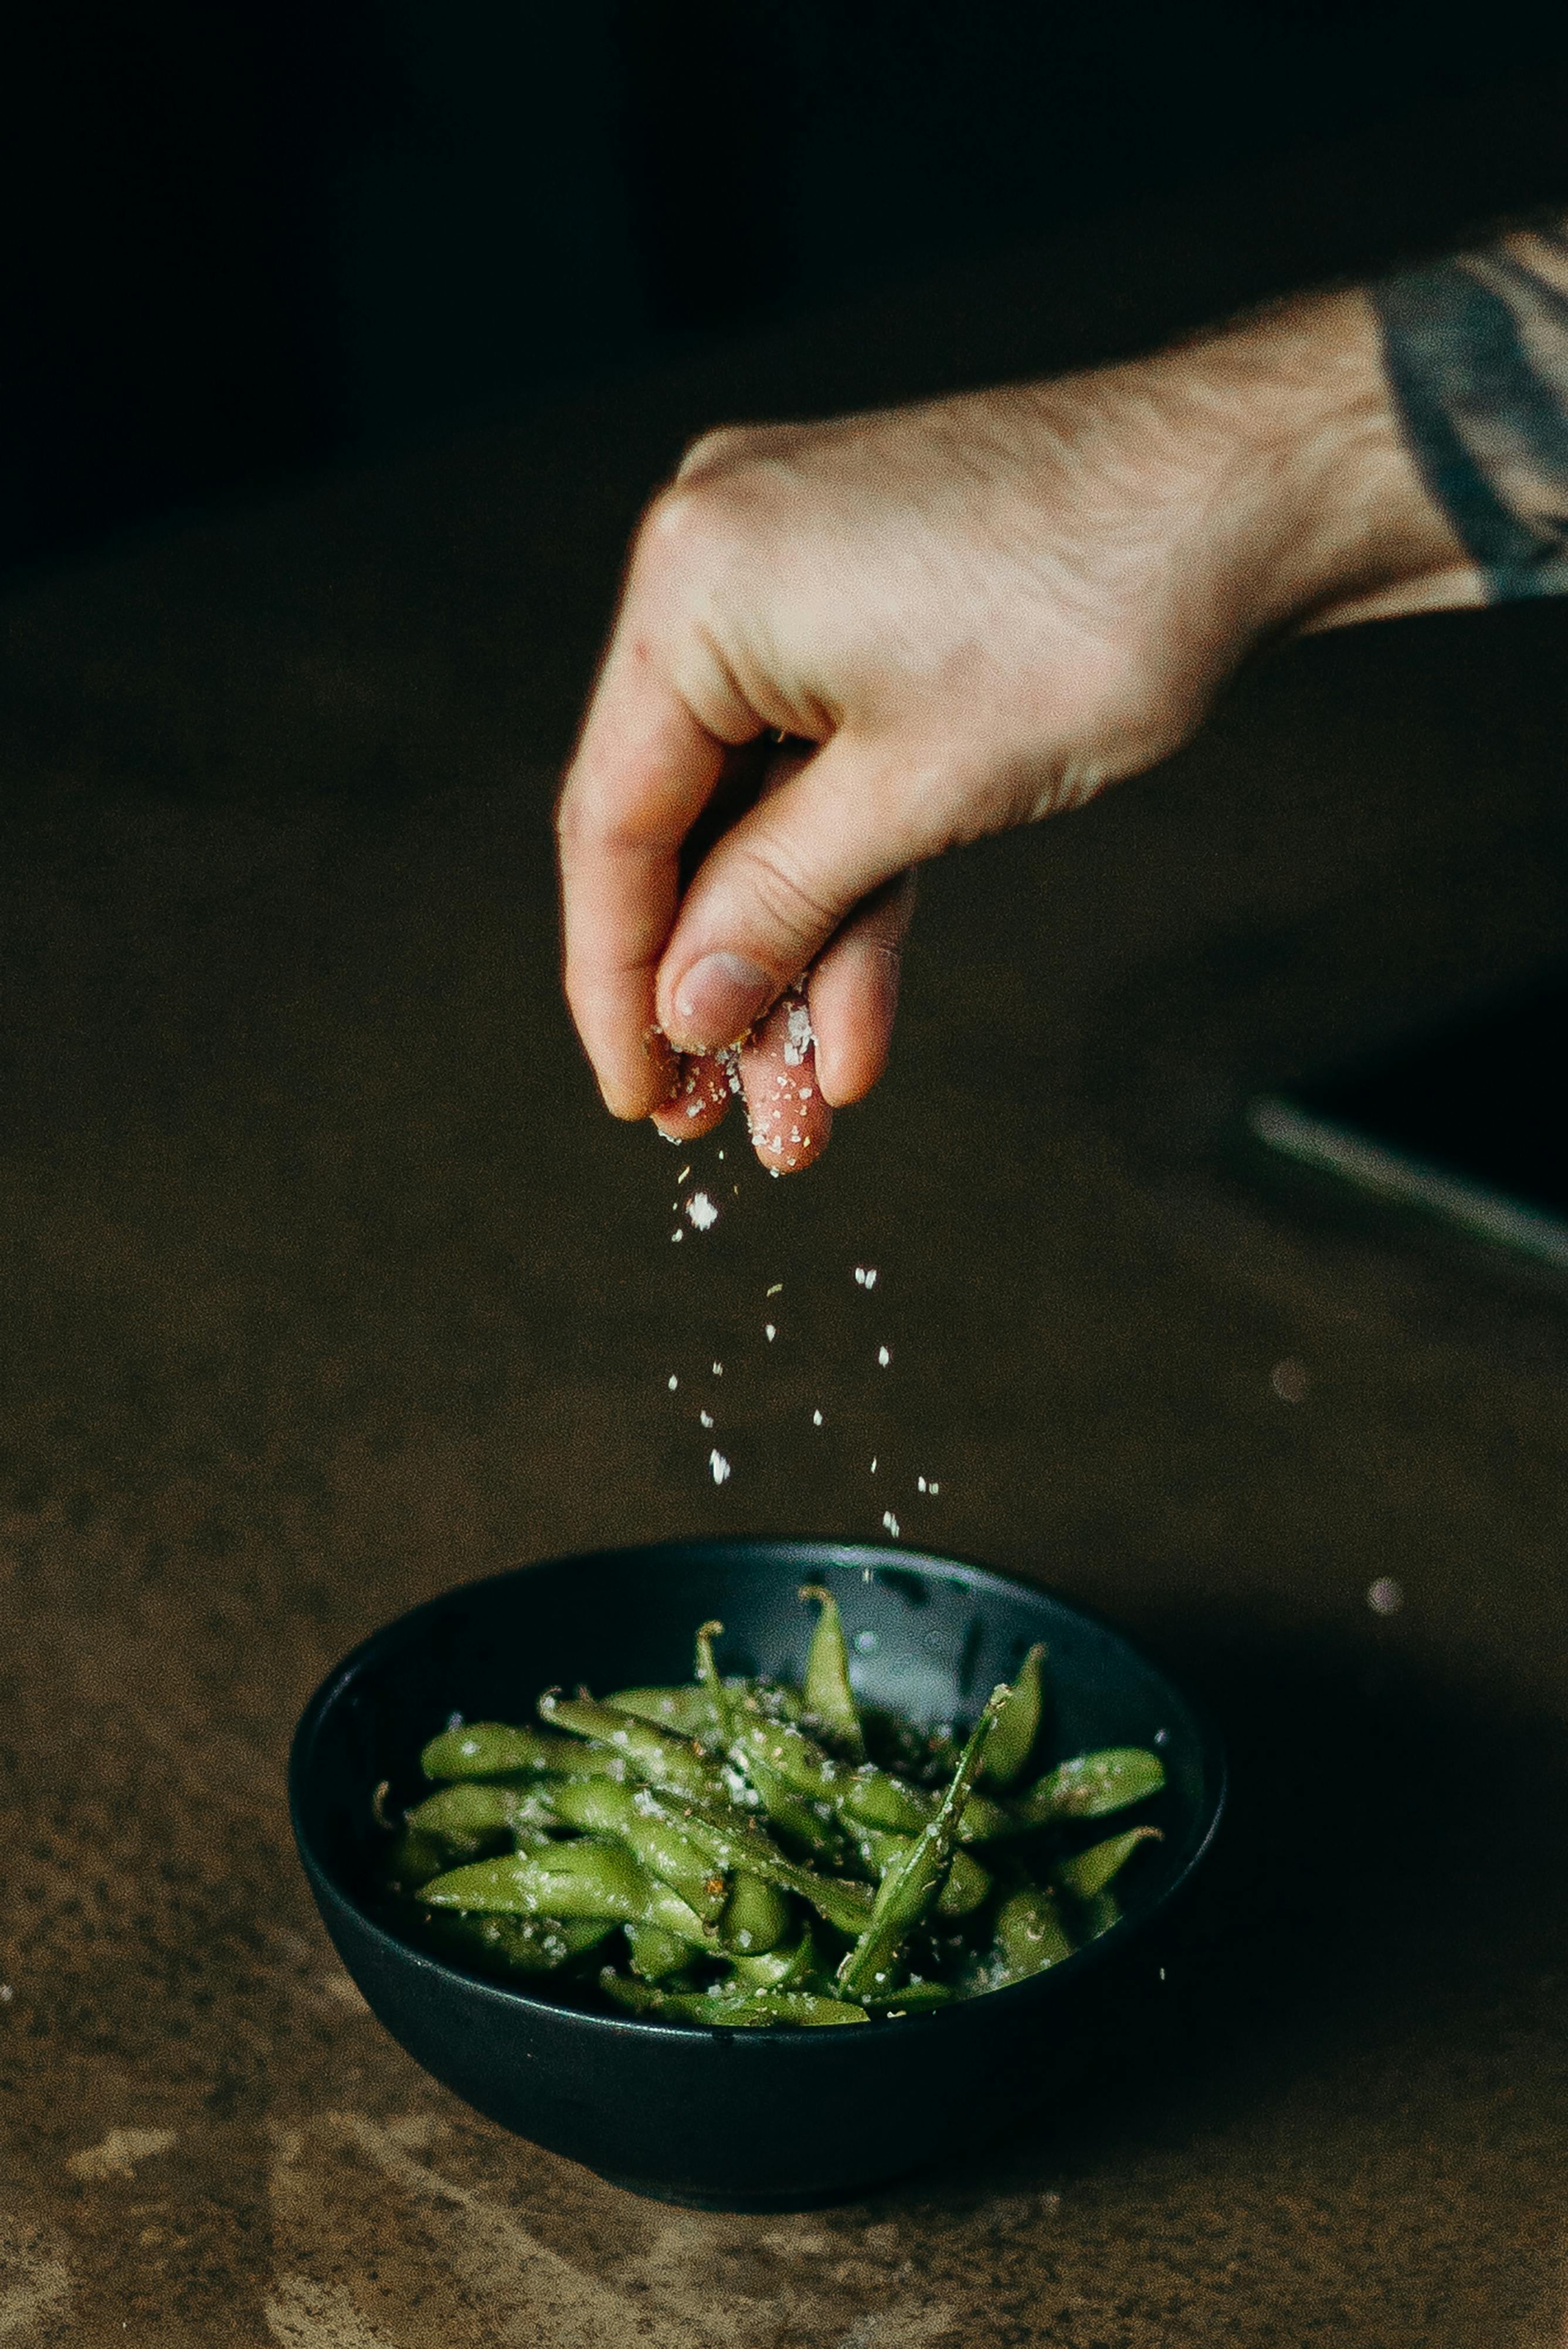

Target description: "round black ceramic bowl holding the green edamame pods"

left=289, top=1541, right=1226, bottom=2211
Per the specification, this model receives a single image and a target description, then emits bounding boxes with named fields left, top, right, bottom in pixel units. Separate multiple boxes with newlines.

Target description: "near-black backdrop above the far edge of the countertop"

left=0, top=0, right=1568, bottom=573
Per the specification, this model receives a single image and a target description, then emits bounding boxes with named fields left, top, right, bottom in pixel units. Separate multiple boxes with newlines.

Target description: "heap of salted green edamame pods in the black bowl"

left=392, top=1585, right=1164, bottom=2029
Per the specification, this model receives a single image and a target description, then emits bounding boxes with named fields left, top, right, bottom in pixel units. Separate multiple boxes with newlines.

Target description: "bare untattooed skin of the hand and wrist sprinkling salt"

left=559, top=291, right=1484, bottom=1172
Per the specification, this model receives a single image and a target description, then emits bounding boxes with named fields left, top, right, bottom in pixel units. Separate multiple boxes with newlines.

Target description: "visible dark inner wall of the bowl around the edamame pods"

left=291, top=1541, right=1223, bottom=1997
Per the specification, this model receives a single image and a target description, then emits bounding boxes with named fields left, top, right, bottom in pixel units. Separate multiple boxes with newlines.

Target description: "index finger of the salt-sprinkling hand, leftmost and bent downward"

left=556, top=632, right=728, bottom=1118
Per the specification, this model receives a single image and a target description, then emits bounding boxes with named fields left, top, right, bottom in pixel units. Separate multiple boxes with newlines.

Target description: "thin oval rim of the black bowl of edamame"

left=289, top=1534, right=1230, bottom=2048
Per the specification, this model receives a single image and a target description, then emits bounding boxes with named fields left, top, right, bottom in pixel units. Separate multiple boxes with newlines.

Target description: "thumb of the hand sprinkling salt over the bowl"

left=657, top=731, right=953, bottom=1052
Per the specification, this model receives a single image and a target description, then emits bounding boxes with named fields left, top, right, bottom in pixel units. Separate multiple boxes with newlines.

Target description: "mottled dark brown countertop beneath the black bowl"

left=0, top=151, right=1568, bottom=2349
